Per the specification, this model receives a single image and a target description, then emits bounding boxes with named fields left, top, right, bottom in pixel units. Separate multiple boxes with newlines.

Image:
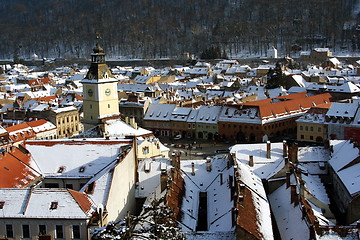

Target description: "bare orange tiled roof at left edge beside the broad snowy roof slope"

left=0, top=148, right=40, bottom=188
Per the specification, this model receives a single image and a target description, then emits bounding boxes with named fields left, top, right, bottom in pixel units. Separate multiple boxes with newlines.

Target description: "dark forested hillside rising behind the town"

left=0, top=0, right=360, bottom=59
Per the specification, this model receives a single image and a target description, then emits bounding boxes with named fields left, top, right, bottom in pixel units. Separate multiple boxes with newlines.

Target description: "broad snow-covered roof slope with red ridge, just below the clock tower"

left=26, top=139, right=130, bottom=178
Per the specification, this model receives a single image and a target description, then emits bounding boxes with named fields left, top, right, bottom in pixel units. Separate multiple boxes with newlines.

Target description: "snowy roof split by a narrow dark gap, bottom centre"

left=181, top=156, right=234, bottom=232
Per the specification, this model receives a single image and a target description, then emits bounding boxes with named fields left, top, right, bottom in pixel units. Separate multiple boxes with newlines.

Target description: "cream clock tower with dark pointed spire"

left=81, top=37, right=120, bottom=130
